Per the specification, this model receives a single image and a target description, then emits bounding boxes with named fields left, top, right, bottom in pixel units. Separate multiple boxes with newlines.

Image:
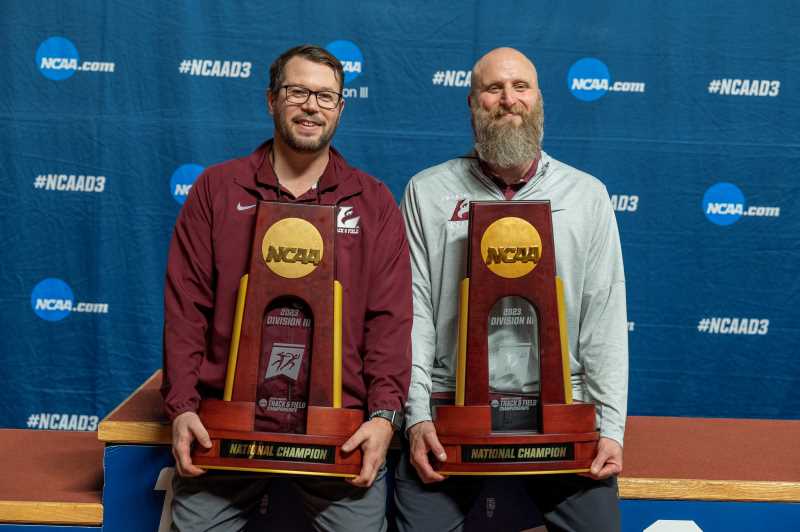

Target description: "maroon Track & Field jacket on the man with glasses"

left=162, top=141, right=412, bottom=419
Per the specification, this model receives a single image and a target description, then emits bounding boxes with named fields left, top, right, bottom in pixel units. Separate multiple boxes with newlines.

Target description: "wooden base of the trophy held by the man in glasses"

left=192, top=399, right=364, bottom=477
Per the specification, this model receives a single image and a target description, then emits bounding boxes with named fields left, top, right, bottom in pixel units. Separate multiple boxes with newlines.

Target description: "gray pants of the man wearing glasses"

left=172, top=466, right=387, bottom=532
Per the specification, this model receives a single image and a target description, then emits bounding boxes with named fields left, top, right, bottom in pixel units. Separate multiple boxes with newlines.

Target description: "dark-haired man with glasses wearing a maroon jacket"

left=162, top=45, right=411, bottom=530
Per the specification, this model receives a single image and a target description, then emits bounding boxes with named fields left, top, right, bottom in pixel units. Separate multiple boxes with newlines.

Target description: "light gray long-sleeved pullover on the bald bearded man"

left=401, top=152, right=628, bottom=444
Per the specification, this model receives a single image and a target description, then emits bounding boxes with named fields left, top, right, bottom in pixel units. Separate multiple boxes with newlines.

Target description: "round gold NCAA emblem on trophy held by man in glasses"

left=261, top=218, right=323, bottom=279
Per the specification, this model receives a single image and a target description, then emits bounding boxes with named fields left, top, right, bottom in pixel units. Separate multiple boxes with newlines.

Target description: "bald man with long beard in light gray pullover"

left=395, top=48, right=628, bottom=532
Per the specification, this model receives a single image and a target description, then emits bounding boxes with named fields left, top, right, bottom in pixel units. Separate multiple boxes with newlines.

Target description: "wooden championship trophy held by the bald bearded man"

left=433, top=201, right=599, bottom=475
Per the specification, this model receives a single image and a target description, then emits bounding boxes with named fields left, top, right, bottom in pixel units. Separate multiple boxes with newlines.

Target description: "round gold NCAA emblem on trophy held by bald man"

left=481, top=216, right=542, bottom=279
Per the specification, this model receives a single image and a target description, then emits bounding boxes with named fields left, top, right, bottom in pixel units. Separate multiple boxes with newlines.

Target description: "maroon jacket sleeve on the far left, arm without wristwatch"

left=161, top=173, right=214, bottom=420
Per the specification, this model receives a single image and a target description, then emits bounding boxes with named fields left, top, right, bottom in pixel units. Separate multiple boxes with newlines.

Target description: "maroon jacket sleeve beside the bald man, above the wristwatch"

left=364, top=185, right=412, bottom=412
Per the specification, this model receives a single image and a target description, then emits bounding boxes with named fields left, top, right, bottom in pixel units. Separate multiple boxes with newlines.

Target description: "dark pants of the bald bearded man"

left=394, top=452, right=620, bottom=532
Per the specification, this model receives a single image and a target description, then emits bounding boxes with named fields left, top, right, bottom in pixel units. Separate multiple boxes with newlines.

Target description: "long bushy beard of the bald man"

left=472, top=98, right=544, bottom=168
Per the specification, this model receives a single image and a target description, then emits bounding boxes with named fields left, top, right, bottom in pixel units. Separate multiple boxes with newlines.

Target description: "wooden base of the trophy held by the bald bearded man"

left=434, top=402, right=600, bottom=475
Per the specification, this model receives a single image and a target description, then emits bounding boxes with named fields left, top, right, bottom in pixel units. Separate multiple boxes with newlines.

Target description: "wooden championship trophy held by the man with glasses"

left=192, top=202, right=364, bottom=477
